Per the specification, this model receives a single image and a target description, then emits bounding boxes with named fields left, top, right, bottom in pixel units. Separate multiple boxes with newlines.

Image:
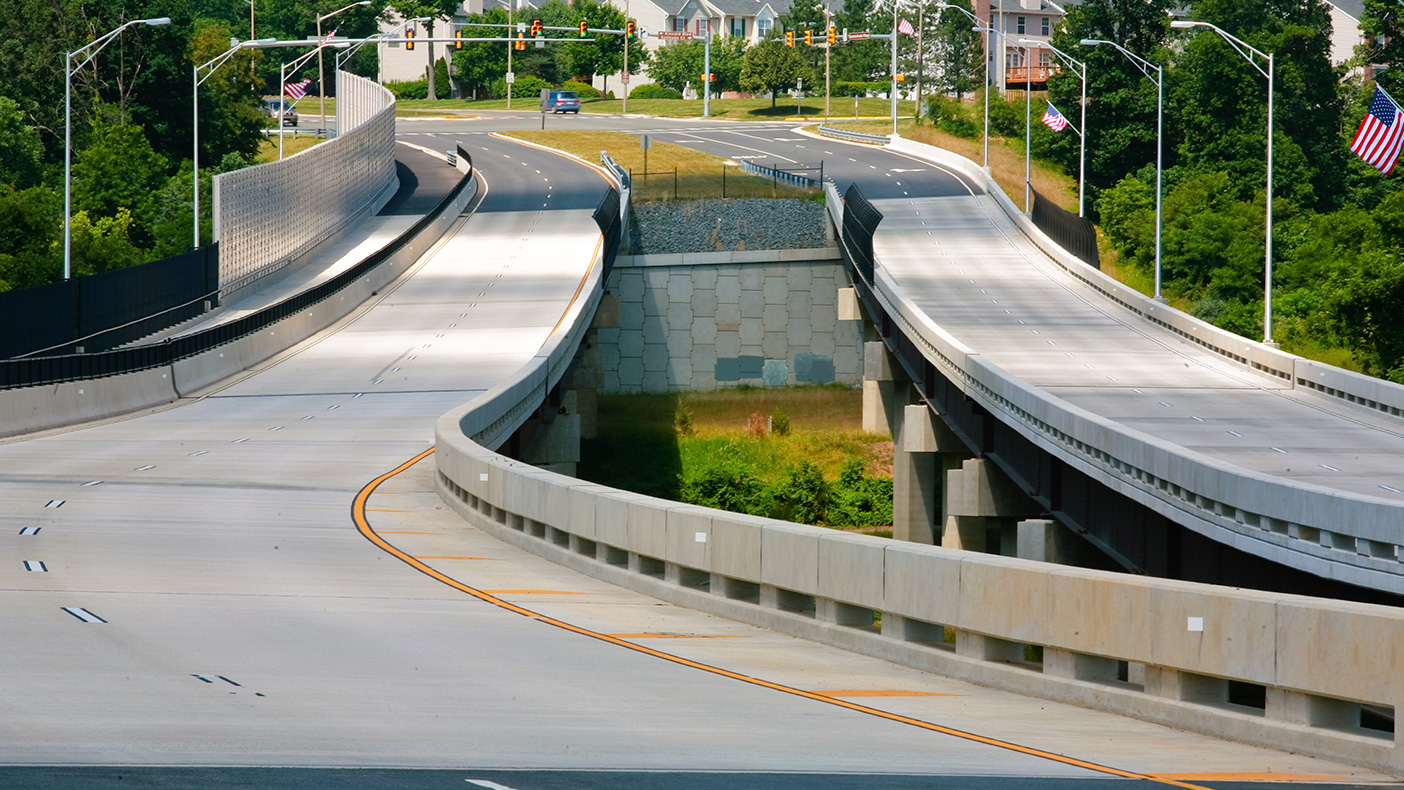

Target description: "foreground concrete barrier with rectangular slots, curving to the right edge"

left=435, top=420, right=1404, bottom=772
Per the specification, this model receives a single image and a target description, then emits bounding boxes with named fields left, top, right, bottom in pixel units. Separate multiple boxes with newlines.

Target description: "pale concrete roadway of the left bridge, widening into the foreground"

left=0, top=111, right=1404, bottom=790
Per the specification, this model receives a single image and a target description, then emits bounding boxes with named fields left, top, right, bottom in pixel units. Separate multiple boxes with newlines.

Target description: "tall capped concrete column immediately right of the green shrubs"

left=892, top=403, right=965, bottom=544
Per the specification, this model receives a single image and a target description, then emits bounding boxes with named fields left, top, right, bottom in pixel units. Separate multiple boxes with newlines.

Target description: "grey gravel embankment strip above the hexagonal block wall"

left=629, top=198, right=826, bottom=255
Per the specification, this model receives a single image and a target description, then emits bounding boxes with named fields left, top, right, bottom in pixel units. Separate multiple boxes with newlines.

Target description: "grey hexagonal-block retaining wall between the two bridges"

left=595, top=248, right=862, bottom=393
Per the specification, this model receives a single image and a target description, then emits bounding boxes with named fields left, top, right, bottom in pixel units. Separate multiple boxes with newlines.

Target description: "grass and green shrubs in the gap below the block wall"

left=578, top=387, right=892, bottom=528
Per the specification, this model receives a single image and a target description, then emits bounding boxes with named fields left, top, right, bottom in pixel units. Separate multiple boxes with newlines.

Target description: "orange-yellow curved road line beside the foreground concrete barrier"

left=351, top=448, right=1213, bottom=790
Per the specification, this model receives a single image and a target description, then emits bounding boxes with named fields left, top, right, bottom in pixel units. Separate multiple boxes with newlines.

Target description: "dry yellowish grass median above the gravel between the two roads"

left=503, top=130, right=814, bottom=202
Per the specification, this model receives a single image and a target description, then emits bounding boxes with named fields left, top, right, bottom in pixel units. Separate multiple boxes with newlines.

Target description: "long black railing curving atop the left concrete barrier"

left=0, top=146, right=473, bottom=389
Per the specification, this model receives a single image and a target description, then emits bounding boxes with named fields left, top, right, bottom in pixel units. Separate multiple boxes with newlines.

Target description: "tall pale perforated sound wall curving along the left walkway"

left=213, top=72, right=395, bottom=293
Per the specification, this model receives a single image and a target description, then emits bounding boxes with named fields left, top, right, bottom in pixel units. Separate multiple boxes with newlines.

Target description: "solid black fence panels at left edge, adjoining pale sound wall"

left=0, top=244, right=219, bottom=358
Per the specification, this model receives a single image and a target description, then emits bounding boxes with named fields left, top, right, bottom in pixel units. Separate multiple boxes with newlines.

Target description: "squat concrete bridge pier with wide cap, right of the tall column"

left=941, top=459, right=1038, bottom=556
